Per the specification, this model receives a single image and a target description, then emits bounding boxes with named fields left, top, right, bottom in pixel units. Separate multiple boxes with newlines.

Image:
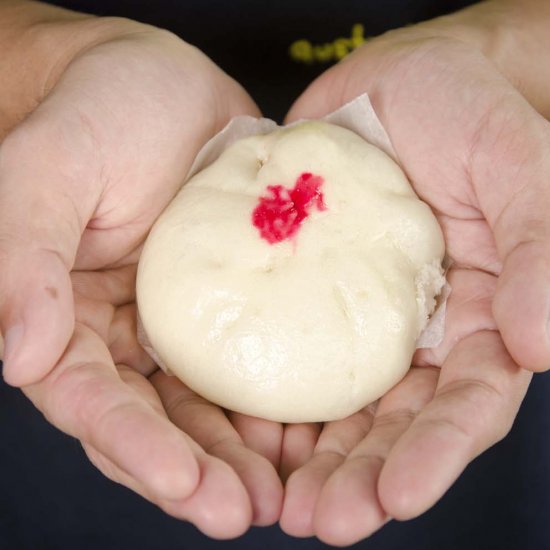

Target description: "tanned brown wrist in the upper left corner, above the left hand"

left=0, top=0, right=148, bottom=141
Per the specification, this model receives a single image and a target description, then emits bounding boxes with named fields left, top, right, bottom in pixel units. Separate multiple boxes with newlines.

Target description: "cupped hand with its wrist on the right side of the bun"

left=281, top=2, right=550, bottom=545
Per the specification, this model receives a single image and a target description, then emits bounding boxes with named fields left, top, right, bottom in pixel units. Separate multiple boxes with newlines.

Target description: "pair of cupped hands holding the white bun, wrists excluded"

left=0, top=8, right=550, bottom=545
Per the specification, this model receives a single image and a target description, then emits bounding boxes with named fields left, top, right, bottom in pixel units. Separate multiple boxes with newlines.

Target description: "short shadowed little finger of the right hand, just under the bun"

left=279, top=423, right=321, bottom=483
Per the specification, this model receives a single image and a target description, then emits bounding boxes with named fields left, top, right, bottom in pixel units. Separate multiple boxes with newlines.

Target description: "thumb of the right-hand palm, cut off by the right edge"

left=471, top=101, right=550, bottom=371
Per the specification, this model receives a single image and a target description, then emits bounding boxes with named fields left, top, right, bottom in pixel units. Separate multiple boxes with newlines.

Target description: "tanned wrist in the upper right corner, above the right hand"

left=419, top=0, right=550, bottom=118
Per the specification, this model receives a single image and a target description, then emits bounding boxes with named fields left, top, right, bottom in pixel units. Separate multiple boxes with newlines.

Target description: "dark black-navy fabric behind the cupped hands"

left=0, top=0, right=550, bottom=550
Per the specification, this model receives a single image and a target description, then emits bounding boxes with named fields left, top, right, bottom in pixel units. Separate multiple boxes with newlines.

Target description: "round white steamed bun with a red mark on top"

left=137, top=122, right=444, bottom=422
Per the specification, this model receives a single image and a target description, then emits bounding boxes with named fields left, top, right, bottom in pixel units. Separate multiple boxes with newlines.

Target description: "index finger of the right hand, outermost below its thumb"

left=378, top=331, right=531, bottom=519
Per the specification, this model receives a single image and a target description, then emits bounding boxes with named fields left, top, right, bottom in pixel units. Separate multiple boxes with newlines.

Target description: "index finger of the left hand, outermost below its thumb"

left=24, top=325, right=200, bottom=506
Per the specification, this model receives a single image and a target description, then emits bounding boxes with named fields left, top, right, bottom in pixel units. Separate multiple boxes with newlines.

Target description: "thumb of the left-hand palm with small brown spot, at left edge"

left=0, top=106, right=100, bottom=386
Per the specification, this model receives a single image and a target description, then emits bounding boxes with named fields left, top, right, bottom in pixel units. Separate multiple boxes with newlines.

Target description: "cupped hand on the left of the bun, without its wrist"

left=0, top=11, right=282, bottom=538
